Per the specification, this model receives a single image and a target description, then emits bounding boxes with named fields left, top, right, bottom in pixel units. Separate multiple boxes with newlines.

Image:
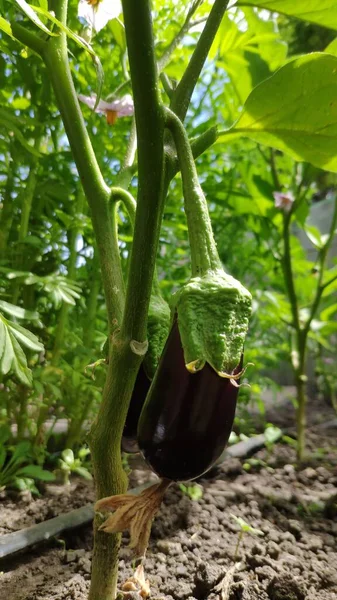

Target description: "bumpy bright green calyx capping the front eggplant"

left=173, top=269, right=252, bottom=378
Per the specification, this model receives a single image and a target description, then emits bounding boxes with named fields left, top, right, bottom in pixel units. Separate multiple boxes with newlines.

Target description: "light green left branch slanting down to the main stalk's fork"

left=42, top=0, right=124, bottom=331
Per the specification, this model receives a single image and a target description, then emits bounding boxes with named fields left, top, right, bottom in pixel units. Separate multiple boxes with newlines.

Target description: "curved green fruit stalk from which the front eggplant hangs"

left=166, top=109, right=221, bottom=276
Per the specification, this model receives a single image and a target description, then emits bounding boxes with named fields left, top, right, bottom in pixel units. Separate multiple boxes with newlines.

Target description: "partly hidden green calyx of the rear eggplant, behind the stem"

left=144, top=292, right=171, bottom=379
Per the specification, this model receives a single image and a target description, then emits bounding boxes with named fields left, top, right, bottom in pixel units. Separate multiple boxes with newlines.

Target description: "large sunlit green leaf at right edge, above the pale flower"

left=220, top=52, right=337, bottom=172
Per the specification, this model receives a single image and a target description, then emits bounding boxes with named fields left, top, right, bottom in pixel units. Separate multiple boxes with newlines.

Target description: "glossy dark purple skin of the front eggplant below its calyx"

left=138, top=321, right=243, bottom=481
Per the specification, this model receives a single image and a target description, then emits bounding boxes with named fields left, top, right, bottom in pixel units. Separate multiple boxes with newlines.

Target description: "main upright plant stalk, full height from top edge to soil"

left=89, top=0, right=164, bottom=600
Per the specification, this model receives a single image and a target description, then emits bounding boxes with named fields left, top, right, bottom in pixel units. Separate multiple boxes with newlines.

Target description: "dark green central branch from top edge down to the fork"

left=121, top=0, right=164, bottom=342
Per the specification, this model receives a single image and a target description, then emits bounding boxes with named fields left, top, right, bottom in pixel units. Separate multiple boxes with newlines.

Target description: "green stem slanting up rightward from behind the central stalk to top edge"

left=171, top=0, right=229, bottom=121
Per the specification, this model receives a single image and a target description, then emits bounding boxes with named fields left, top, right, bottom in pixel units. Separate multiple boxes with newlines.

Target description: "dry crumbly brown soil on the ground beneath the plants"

left=0, top=394, right=337, bottom=600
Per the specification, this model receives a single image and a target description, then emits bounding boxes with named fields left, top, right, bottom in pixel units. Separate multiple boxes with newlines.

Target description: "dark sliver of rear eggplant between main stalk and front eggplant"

left=122, top=364, right=151, bottom=453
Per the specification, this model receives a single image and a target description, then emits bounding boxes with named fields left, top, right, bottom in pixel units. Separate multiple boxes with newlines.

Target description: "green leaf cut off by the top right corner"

left=236, top=0, right=337, bottom=29
